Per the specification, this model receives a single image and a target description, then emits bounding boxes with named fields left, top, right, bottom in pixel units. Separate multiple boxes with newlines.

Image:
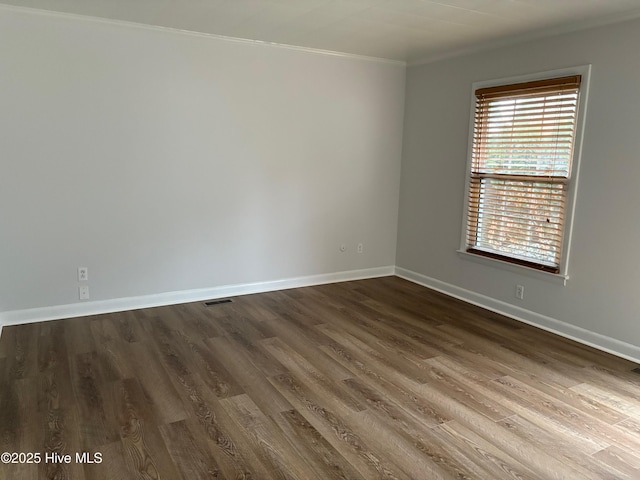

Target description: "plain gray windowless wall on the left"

left=0, top=7, right=405, bottom=314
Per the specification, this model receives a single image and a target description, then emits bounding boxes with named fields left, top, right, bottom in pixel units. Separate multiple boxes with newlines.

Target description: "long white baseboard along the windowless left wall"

left=0, top=266, right=395, bottom=335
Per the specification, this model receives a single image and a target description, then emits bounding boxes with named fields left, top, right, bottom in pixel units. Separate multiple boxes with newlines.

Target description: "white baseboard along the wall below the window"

left=395, top=267, right=640, bottom=363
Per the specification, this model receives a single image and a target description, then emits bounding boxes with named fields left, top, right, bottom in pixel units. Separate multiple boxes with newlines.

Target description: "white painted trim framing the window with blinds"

left=458, top=65, right=591, bottom=284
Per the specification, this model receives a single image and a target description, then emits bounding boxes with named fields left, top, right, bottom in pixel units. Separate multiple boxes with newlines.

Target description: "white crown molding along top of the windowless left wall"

left=0, top=4, right=407, bottom=67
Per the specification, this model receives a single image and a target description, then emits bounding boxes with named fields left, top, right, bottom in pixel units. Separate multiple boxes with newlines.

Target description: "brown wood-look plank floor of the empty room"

left=0, top=277, right=640, bottom=480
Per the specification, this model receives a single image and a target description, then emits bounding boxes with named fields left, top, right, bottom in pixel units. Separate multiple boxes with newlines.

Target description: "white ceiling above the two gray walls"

left=0, top=0, right=640, bottom=63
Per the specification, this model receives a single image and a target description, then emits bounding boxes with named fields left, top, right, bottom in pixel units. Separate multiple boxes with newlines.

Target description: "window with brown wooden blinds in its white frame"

left=463, top=69, right=583, bottom=274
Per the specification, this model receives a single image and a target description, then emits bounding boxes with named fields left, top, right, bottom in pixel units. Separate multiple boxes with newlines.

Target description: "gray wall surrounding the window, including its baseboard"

left=396, top=16, right=640, bottom=358
